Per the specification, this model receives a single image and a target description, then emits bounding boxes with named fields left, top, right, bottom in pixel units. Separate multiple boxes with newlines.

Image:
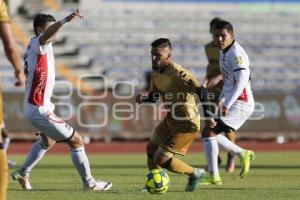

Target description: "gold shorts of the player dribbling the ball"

left=151, top=118, right=200, bottom=155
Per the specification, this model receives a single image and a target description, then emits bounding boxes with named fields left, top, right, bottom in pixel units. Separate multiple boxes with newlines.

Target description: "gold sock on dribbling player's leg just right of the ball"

left=167, top=157, right=194, bottom=175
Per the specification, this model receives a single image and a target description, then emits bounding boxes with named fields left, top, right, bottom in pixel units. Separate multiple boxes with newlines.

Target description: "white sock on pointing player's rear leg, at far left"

left=19, top=140, right=47, bottom=176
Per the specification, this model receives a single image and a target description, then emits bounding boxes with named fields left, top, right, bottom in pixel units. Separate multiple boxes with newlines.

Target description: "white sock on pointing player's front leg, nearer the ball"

left=71, top=146, right=95, bottom=187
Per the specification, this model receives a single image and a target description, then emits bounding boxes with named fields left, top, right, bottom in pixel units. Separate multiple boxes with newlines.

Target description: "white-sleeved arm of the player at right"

left=224, top=56, right=250, bottom=109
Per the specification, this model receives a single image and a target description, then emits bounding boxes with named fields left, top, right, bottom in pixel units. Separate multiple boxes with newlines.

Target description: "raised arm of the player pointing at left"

left=40, top=9, right=83, bottom=45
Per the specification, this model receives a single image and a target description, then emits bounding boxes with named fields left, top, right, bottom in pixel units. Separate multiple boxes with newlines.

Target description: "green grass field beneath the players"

left=8, top=152, right=300, bottom=200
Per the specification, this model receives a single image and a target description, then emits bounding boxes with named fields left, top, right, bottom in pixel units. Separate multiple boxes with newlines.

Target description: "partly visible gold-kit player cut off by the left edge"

left=0, top=0, right=25, bottom=200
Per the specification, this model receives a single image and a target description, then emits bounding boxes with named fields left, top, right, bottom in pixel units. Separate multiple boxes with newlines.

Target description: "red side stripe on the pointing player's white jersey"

left=28, top=54, right=48, bottom=106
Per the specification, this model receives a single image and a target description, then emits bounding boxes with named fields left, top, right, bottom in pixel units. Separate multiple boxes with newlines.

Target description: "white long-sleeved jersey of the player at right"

left=219, top=41, right=253, bottom=109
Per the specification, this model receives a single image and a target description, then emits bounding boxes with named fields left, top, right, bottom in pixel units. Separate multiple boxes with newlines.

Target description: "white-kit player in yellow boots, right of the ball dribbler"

left=201, top=21, right=255, bottom=188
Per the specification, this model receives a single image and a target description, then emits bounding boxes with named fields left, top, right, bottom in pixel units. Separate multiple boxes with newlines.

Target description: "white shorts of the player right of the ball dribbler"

left=220, top=98, right=254, bottom=131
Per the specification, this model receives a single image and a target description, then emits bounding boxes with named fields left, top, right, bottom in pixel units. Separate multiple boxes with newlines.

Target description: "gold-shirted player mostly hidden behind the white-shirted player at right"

left=203, top=17, right=235, bottom=173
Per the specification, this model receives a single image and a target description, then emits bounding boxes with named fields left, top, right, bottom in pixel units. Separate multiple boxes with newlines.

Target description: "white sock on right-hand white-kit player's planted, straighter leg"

left=203, top=136, right=219, bottom=176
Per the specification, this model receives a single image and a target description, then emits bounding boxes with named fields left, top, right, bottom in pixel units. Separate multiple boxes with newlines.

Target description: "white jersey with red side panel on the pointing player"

left=24, top=36, right=55, bottom=111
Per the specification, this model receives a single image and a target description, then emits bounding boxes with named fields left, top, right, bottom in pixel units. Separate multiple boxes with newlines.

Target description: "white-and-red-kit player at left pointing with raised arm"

left=12, top=10, right=112, bottom=191
